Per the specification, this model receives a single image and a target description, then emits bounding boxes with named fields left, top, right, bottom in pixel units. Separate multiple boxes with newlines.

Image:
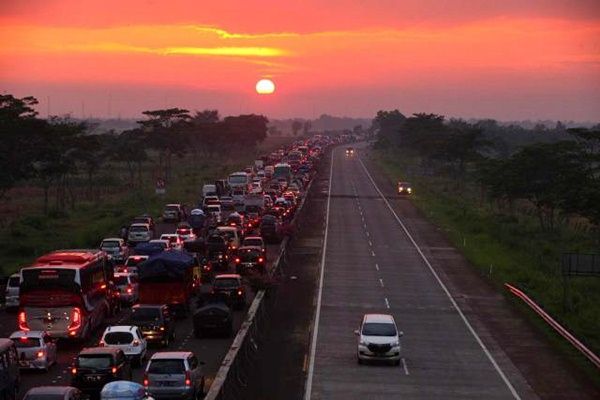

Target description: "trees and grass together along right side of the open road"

left=374, top=110, right=600, bottom=369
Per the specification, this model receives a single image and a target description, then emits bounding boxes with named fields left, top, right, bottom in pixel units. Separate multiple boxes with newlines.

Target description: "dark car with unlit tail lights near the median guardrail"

left=193, top=296, right=233, bottom=338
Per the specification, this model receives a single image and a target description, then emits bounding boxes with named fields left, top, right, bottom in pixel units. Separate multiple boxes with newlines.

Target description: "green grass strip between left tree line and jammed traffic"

left=0, top=137, right=293, bottom=275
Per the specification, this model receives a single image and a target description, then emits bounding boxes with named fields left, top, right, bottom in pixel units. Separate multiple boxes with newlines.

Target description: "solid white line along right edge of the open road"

left=358, top=158, right=521, bottom=400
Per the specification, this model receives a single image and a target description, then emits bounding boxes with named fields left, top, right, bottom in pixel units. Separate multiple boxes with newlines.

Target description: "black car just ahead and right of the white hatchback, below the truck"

left=129, top=304, right=175, bottom=347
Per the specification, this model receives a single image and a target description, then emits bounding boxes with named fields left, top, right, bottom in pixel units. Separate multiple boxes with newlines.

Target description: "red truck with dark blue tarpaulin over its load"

left=138, top=250, right=199, bottom=315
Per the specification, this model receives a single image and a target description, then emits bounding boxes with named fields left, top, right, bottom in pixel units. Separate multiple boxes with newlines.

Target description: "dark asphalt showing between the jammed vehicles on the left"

left=0, top=223, right=279, bottom=396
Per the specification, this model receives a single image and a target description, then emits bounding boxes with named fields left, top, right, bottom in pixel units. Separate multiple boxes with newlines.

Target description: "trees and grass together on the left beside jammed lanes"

left=0, top=95, right=291, bottom=275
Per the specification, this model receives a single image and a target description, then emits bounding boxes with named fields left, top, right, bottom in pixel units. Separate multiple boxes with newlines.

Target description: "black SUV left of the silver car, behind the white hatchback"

left=71, top=347, right=131, bottom=397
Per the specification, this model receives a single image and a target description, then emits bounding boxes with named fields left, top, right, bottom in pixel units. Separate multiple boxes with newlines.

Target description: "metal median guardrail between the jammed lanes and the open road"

left=204, top=173, right=314, bottom=400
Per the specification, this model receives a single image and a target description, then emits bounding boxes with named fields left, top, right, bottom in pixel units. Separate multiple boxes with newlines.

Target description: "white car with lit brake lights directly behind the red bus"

left=10, top=331, right=57, bottom=372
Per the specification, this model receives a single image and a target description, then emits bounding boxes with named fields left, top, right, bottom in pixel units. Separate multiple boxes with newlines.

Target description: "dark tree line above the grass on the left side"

left=0, top=94, right=268, bottom=213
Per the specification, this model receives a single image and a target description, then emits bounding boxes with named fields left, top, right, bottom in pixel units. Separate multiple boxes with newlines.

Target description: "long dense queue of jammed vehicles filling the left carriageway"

left=0, top=135, right=333, bottom=400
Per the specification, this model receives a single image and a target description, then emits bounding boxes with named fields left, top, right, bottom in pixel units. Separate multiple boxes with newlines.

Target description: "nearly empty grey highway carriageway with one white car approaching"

left=305, top=147, right=536, bottom=400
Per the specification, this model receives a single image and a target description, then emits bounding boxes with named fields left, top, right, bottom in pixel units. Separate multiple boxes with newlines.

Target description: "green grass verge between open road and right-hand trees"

left=374, top=150, right=600, bottom=385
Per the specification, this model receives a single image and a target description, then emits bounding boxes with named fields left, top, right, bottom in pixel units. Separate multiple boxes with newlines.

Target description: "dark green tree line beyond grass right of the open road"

left=373, top=110, right=600, bottom=231
